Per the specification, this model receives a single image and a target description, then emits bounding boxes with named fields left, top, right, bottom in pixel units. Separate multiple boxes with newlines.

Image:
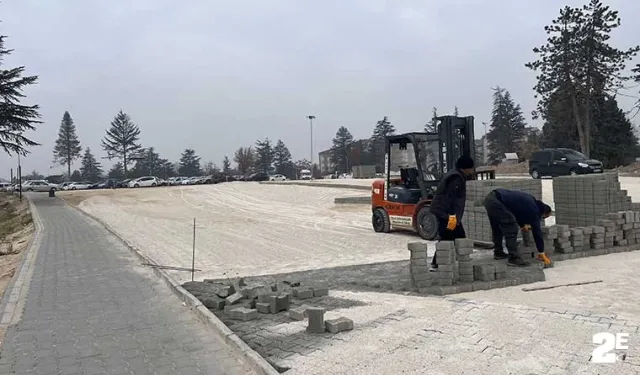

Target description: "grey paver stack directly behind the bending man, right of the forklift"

left=462, top=179, right=542, bottom=242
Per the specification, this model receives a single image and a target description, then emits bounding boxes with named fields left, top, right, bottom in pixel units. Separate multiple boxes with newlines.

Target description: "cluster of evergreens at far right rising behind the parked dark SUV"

left=487, top=0, right=640, bottom=167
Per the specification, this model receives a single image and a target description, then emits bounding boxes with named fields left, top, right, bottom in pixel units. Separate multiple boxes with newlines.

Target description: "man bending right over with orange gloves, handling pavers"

left=484, top=189, right=551, bottom=266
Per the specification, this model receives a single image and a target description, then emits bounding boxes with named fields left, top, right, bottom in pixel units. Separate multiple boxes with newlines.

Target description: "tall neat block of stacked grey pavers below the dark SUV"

left=553, top=173, right=632, bottom=227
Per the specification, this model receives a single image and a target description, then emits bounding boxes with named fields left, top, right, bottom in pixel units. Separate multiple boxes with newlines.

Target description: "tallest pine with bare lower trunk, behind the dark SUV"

left=526, top=0, right=640, bottom=156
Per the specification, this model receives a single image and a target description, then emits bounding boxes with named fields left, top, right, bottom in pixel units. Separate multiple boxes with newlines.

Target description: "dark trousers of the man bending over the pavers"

left=484, top=191, right=520, bottom=257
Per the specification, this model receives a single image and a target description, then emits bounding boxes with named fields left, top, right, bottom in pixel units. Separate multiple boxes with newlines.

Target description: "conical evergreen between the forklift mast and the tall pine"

left=487, top=87, right=527, bottom=164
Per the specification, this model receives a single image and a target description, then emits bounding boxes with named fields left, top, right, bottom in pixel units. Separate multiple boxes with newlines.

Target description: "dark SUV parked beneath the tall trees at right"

left=529, top=148, right=603, bottom=178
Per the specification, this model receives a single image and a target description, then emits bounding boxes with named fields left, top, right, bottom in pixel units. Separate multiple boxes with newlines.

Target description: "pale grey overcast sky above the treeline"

left=0, top=0, right=640, bottom=177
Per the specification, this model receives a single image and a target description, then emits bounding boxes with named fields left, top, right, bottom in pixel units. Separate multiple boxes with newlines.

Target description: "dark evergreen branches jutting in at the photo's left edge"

left=0, top=35, right=42, bottom=155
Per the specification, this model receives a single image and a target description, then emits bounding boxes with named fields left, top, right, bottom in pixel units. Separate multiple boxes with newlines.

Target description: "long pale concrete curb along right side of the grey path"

left=62, top=198, right=280, bottom=375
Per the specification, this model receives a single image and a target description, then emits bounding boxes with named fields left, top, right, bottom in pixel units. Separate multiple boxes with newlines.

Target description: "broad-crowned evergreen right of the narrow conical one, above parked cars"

left=102, top=110, right=142, bottom=175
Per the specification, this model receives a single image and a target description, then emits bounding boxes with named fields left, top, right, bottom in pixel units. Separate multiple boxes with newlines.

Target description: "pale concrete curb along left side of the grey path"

left=0, top=196, right=42, bottom=348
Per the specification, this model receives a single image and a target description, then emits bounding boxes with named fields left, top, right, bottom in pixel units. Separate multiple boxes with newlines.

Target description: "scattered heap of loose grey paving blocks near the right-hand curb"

left=183, top=278, right=353, bottom=333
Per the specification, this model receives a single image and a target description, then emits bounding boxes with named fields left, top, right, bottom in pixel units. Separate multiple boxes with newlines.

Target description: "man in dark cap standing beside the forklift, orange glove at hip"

left=430, top=155, right=475, bottom=270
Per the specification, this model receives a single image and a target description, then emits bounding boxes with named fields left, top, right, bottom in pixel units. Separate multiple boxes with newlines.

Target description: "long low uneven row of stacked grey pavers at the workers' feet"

left=408, top=211, right=640, bottom=295
